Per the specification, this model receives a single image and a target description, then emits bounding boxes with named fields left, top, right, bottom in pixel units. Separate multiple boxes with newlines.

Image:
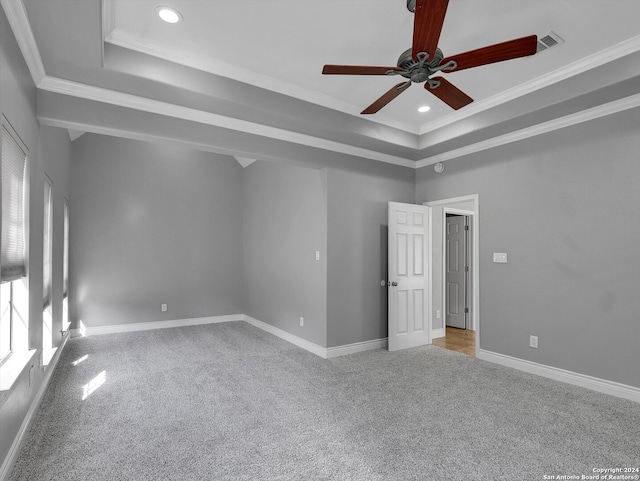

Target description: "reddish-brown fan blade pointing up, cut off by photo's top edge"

left=411, top=0, right=449, bottom=60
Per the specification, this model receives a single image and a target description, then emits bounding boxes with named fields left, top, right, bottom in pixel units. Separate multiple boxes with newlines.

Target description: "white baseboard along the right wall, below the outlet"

left=476, top=349, right=640, bottom=402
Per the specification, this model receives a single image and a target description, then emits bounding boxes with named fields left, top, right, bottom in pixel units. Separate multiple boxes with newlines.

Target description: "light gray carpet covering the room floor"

left=10, top=322, right=640, bottom=481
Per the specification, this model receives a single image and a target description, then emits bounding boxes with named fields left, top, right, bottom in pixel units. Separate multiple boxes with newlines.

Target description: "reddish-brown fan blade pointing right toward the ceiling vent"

left=440, top=35, right=538, bottom=72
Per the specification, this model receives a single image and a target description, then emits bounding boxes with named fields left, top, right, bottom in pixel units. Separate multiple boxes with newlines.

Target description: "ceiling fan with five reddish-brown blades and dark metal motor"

left=322, top=0, right=538, bottom=114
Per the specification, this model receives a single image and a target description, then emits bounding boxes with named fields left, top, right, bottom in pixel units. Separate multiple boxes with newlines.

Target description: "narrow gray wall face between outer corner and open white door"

left=327, top=162, right=415, bottom=347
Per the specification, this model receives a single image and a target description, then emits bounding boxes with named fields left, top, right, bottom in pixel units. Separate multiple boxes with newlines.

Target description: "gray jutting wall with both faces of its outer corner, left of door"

left=243, top=161, right=415, bottom=347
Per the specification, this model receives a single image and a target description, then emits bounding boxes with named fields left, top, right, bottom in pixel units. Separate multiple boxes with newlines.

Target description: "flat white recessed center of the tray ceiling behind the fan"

left=109, top=0, right=640, bottom=134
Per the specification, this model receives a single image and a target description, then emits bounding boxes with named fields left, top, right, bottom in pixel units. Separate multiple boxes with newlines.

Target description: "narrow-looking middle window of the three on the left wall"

left=42, top=175, right=53, bottom=365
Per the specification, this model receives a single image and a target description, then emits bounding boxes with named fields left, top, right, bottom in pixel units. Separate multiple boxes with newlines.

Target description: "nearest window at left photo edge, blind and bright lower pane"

left=0, top=117, right=28, bottom=363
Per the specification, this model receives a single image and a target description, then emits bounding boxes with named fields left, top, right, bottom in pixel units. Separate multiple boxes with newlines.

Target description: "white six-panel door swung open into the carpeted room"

left=387, top=202, right=431, bottom=351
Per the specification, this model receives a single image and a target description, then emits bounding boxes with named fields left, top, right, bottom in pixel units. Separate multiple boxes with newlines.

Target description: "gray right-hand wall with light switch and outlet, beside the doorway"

left=416, top=109, right=640, bottom=387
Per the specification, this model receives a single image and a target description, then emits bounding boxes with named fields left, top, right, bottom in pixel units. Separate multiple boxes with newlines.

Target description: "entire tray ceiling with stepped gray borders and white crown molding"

left=7, top=0, right=640, bottom=169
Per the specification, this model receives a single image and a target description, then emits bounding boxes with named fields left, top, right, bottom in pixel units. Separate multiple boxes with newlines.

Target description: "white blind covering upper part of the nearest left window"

left=0, top=125, right=27, bottom=283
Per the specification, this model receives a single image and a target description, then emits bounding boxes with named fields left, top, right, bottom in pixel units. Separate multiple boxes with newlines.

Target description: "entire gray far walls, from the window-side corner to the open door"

left=70, top=134, right=415, bottom=347
